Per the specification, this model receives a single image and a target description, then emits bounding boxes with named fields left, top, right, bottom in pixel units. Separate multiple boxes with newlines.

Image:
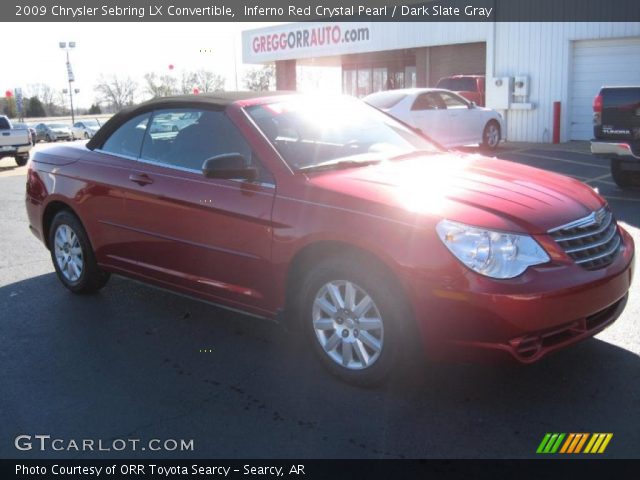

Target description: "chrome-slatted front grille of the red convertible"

left=549, top=207, right=621, bottom=270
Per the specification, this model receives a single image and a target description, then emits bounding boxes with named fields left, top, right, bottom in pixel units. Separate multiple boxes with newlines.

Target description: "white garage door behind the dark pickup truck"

left=570, top=38, right=640, bottom=140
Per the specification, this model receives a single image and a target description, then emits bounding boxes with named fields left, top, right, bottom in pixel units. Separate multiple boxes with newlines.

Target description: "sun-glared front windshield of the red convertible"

left=247, top=97, right=439, bottom=170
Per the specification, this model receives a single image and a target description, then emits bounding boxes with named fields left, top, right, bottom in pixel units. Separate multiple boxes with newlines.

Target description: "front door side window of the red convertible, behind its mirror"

left=141, top=109, right=254, bottom=171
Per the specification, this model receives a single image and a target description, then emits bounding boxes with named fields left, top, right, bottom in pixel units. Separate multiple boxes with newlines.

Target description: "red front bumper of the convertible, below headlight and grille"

left=413, top=229, right=634, bottom=363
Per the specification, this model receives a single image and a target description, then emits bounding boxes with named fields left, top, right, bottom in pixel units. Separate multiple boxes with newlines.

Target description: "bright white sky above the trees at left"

left=0, top=22, right=284, bottom=107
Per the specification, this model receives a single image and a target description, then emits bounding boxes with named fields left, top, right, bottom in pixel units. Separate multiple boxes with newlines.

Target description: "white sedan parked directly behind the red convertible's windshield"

left=364, top=88, right=504, bottom=150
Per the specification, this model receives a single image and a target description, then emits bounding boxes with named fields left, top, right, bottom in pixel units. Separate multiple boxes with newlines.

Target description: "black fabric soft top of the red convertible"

left=87, top=91, right=295, bottom=150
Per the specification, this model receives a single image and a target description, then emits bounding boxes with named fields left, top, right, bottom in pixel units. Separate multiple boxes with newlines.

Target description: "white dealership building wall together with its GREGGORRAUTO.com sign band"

left=242, top=22, right=640, bottom=142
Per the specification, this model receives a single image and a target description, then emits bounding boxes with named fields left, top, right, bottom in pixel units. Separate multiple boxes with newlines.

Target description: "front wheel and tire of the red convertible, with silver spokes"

left=297, top=256, right=410, bottom=386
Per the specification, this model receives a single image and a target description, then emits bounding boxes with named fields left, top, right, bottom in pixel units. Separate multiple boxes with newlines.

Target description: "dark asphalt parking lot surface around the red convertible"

left=0, top=143, right=640, bottom=459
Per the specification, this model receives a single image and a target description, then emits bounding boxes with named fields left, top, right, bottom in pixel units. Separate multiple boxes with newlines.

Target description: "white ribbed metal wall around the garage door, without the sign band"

left=487, top=22, right=640, bottom=142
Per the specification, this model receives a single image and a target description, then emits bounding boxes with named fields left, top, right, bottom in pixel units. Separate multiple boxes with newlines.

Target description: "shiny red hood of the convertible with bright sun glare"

left=308, top=152, right=605, bottom=234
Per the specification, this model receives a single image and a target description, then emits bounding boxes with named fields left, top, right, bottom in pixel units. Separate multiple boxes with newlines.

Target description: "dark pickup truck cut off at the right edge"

left=591, top=86, right=640, bottom=188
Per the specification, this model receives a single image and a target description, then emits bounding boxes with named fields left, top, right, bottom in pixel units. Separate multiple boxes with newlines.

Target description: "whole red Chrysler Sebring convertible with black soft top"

left=26, top=93, right=634, bottom=384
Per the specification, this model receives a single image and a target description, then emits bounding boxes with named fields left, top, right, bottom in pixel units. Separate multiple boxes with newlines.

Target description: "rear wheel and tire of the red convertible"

left=48, top=210, right=109, bottom=294
